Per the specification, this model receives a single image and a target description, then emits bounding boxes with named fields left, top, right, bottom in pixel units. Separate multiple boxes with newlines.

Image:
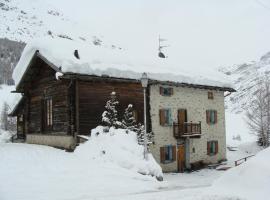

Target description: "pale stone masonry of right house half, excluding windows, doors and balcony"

left=150, top=85, right=226, bottom=172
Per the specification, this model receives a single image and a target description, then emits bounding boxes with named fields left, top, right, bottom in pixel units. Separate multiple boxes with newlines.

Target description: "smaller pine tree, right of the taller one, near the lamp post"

left=122, top=104, right=137, bottom=132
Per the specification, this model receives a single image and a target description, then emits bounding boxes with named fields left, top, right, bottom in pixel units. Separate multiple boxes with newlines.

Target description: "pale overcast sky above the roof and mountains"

left=50, top=0, right=270, bottom=71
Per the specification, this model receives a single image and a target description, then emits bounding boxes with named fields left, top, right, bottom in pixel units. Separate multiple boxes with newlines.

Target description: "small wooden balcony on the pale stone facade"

left=173, top=121, right=201, bottom=139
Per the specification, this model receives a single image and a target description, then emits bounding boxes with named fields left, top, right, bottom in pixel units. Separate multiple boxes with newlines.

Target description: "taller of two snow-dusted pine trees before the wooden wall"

left=102, top=92, right=121, bottom=128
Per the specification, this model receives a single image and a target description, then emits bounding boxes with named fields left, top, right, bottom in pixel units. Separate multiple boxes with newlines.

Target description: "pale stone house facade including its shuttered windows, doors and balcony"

left=149, top=84, right=226, bottom=172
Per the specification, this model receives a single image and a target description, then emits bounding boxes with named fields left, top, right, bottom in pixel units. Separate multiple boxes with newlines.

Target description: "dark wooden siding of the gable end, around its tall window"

left=25, top=59, right=69, bottom=133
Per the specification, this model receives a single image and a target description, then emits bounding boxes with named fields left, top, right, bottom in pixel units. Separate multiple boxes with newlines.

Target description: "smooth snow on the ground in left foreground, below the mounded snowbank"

left=0, top=143, right=160, bottom=200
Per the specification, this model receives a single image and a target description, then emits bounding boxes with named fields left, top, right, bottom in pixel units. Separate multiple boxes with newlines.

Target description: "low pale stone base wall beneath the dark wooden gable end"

left=26, top=134, right=76, bottom=149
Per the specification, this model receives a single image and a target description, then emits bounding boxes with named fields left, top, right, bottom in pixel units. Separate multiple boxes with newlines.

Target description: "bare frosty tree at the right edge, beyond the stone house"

left=246, top=77, right=270, bottom=147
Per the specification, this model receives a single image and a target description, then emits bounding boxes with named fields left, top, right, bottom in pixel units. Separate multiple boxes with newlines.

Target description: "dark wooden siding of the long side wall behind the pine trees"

left=78, top=79, right=146, bottom=134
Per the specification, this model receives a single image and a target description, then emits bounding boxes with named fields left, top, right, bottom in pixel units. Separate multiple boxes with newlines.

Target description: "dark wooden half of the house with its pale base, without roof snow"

left=11, top=52, right=147, bottom=150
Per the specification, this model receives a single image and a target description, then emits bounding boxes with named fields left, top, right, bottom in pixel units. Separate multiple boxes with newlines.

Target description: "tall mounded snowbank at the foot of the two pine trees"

left=75, top=126, right=163, bottom=178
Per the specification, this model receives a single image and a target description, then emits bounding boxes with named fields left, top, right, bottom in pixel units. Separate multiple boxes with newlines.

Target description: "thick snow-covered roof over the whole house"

left=13, top=37, right=235, bottom=88
